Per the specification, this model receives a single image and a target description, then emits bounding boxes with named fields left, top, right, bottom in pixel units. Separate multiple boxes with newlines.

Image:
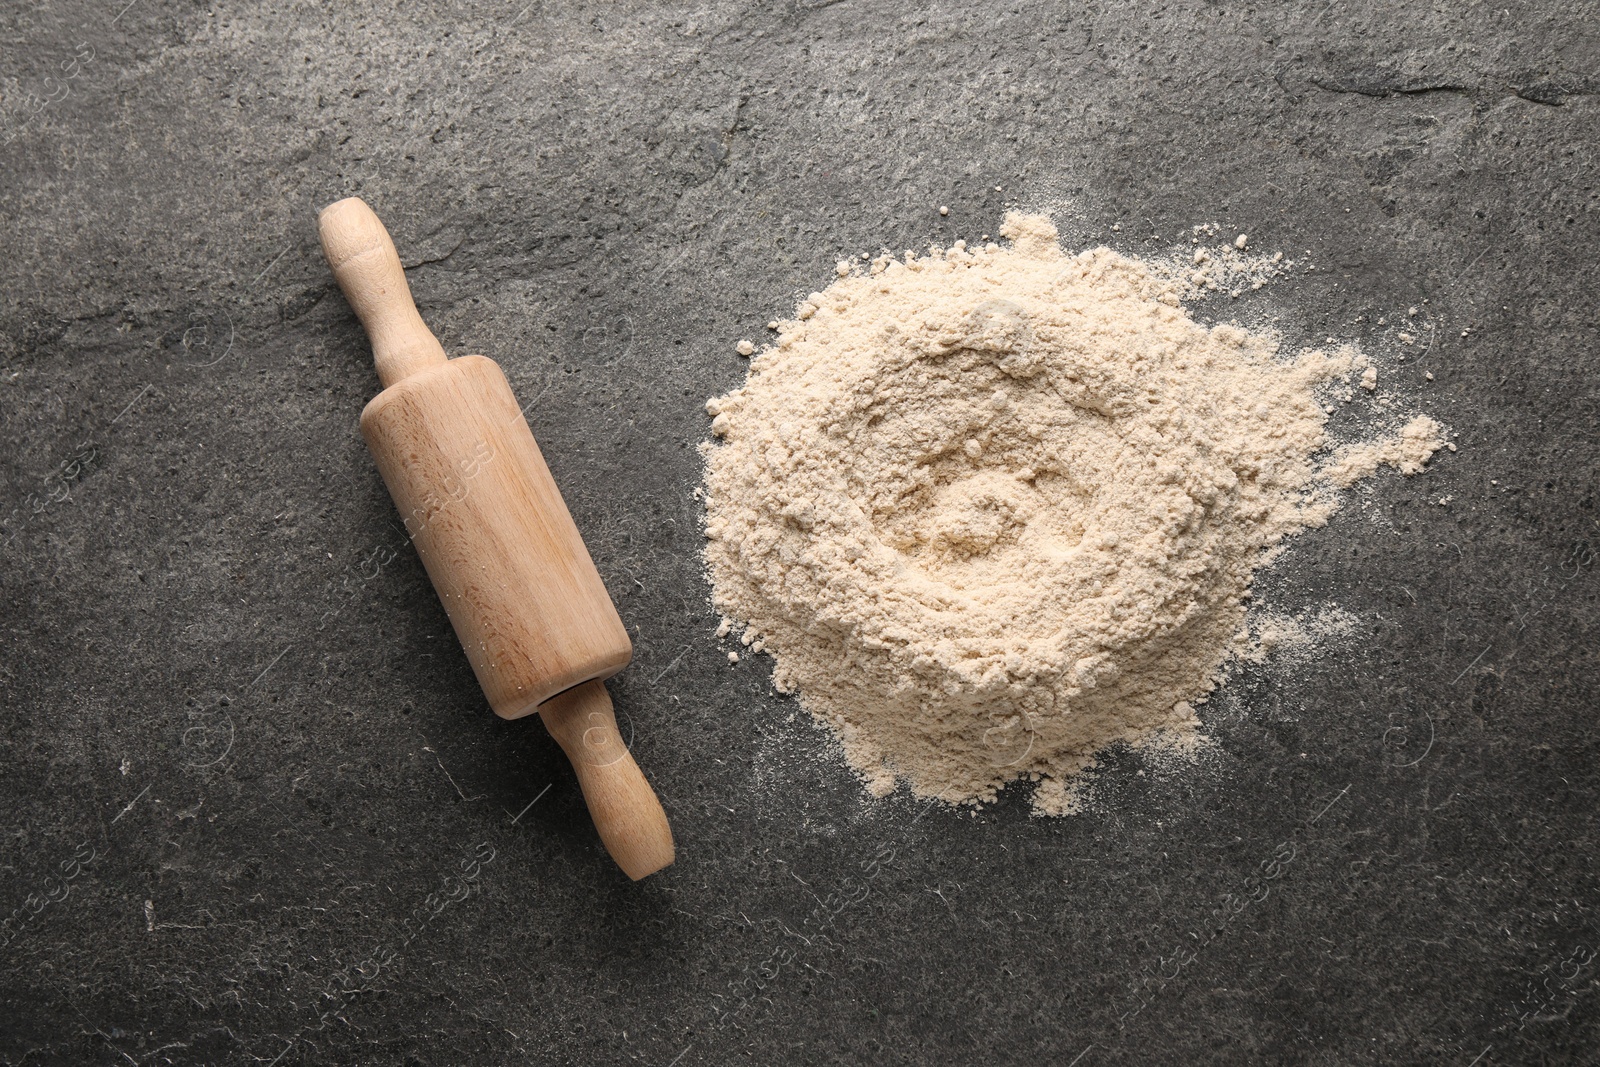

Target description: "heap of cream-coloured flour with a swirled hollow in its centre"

left=702, top=214, right=1443, bottom=814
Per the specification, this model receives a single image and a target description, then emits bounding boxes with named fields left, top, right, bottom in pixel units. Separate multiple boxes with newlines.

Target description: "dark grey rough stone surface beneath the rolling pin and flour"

left=0, top=0, right=1600, bottom=1067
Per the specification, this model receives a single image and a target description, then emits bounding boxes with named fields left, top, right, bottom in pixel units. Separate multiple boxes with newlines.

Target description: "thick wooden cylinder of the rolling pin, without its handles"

left=362, top=355, right=634, bottom=718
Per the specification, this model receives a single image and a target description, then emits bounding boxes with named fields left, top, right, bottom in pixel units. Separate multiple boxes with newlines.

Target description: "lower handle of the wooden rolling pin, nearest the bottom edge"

left=539, top=678, right=675, bottom=881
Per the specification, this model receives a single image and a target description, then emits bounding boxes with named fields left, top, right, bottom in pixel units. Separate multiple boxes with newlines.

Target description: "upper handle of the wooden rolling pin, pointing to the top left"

left=317, top=197, right=445, bottom=389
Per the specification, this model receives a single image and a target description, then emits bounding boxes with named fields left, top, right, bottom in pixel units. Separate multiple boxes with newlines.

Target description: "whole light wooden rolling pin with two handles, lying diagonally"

left=317, top=197, right=674, bottom=878
